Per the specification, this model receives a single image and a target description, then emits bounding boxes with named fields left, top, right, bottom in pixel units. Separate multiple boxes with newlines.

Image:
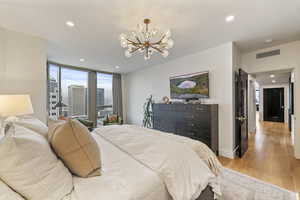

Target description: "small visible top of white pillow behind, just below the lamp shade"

left=14, top=116, right=48, bottom=137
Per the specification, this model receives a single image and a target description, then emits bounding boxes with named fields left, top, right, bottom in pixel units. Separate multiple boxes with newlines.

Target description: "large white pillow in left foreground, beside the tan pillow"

left=0, top=125, right=73, bottom=200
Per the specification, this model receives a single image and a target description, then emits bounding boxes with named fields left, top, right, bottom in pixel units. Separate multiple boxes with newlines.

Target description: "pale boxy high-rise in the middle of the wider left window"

left=68, top=85, right=87, bottom=116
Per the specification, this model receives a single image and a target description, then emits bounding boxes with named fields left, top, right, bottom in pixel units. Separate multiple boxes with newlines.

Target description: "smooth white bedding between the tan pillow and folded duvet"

left=71, top=134, right=171, bottom=200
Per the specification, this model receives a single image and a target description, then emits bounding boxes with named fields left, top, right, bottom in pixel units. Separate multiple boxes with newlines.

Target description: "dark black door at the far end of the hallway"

left=263, top=88, right=284, bottom=122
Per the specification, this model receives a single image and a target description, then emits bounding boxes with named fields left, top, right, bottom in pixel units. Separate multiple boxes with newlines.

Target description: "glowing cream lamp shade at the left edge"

left=0, top=95, right=33, bottom=117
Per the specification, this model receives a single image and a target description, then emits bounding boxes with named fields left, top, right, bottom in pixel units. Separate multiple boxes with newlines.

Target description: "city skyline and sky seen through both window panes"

left=48, top=64, right=113, bottom=125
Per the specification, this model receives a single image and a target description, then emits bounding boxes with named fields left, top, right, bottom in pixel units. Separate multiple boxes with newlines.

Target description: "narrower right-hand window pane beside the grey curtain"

left=96, top=73, right=113, bottom=124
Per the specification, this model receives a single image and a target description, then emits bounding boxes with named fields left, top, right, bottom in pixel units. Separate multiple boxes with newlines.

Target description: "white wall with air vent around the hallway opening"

left=242, top=41, right=300, bottom=159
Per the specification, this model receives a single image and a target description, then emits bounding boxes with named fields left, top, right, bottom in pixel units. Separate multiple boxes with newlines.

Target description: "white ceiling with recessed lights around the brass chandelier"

left=0, top=0, right=300, bottom=73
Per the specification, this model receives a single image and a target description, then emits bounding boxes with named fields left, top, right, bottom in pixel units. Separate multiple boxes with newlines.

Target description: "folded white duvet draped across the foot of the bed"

left=95, top=125, right=215, bottom=200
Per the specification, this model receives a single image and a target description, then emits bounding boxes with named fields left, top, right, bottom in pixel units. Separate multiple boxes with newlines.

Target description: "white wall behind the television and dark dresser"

left=123, top=42, right=234, bottom=157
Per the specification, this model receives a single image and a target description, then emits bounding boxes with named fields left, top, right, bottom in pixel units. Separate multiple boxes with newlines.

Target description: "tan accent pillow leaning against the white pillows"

left=48, top=119, right=101, bottom=177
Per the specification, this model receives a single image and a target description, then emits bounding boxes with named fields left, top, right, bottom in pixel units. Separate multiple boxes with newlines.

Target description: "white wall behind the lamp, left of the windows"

left=0, top=28, right=47, bottom=122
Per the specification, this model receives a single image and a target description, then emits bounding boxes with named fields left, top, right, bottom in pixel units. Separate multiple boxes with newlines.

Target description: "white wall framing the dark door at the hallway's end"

left=259, top=84, right=289, bottom=123
